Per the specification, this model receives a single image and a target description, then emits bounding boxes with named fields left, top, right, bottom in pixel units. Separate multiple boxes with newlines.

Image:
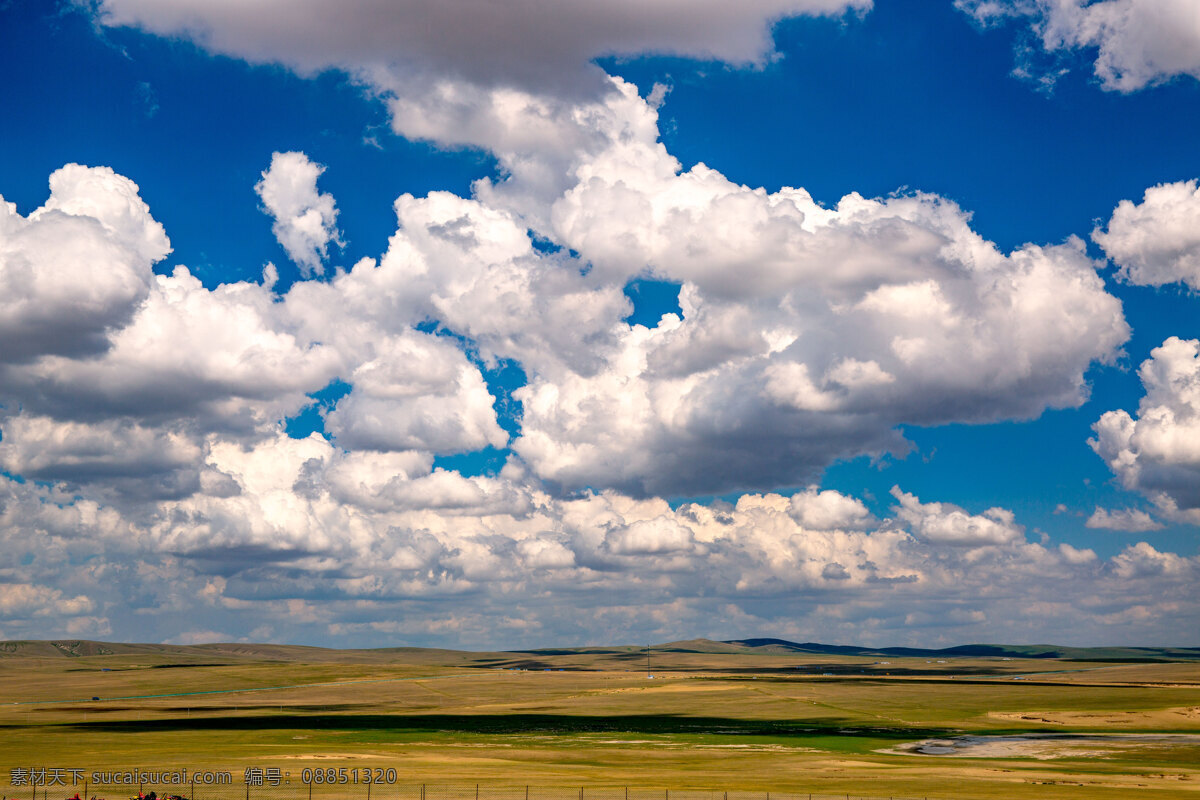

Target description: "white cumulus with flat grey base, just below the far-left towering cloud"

left=5, top=266, right=343, bottom=432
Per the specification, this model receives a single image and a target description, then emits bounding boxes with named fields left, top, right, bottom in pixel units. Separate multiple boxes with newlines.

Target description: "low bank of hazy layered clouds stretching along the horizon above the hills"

left=0, top=455, right=1200, bottom=646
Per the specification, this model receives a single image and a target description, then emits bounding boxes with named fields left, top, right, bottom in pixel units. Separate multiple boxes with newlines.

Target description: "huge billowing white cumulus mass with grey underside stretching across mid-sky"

left=0, top=80, right=1128, bottom=510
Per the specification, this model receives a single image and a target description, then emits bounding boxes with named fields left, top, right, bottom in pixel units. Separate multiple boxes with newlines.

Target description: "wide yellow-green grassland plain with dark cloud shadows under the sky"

left=0, top=642, right=1200, bottom=800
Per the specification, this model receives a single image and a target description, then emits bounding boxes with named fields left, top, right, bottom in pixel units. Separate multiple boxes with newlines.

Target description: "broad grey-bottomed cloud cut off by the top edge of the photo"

left=88, top=0, right=871, bottom=92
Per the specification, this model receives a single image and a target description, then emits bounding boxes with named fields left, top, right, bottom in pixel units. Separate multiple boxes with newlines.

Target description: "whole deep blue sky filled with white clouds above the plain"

left=0, top=0, right=1200, bottom=646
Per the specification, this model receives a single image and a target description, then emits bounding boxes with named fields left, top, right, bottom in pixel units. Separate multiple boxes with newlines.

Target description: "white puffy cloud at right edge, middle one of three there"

left=1092, top=180, right=1200, bottom=289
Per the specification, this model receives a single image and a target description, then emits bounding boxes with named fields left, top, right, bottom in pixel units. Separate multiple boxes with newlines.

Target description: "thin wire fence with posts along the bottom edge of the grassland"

left=0, top=768, right=947, bottom=800
